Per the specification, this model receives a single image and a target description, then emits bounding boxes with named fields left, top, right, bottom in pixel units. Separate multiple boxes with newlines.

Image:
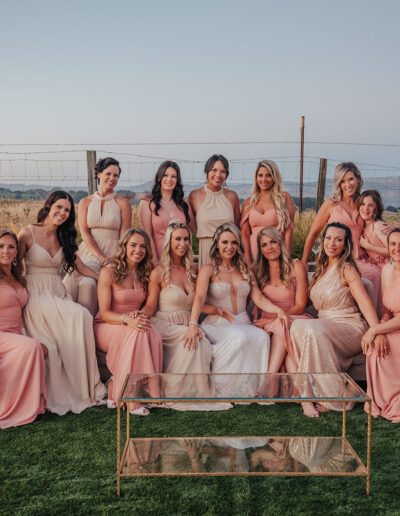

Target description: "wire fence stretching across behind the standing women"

left=0, top=141, right=400, bottom=208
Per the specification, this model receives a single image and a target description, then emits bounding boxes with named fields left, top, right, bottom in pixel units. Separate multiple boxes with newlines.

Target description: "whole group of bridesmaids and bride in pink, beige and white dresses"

left=0, top=155, right=400, bottom=428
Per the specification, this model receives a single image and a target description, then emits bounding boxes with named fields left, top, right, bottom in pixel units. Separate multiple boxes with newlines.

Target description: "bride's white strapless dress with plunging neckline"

left=201, top=281, right=270, bottom=397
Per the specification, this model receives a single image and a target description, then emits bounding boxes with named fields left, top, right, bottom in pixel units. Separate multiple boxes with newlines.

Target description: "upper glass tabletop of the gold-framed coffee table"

left=119, top=373, right=369, bottom=403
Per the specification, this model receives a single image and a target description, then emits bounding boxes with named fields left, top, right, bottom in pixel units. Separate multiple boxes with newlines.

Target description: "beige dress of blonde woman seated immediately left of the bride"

left=152, top=283, right=231, bottom=410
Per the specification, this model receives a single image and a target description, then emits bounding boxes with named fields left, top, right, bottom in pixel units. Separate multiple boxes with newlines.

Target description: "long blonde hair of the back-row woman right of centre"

left=249, top=159, right=290, bottom=232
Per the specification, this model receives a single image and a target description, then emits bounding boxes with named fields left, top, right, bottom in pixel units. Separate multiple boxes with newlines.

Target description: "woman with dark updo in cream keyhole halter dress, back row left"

left=64, top=158, right=132, bottom=315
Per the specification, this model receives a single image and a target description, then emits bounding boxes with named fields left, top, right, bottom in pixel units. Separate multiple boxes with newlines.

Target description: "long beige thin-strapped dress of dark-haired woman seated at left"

left=23, top=231, right=105, bottom=415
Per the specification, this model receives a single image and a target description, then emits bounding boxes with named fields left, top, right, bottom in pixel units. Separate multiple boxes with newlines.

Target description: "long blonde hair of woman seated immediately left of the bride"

left=160, top=220, right=196, bottom=289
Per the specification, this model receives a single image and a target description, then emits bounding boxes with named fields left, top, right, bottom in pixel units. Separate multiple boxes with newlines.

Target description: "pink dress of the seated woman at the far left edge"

left=0, top=283, right=46, bottom=428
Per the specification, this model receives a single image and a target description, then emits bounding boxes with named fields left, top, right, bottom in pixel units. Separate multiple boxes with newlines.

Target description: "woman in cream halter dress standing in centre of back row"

left=189, top=154, right=240, bottom=268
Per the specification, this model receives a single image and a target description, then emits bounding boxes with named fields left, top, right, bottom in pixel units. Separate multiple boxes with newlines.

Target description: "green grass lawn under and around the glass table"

left=0, top=404, right=400, bottom=515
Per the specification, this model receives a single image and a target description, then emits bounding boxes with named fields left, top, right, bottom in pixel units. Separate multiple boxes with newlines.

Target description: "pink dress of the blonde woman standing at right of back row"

left=328, top=202, right=382, bottom=316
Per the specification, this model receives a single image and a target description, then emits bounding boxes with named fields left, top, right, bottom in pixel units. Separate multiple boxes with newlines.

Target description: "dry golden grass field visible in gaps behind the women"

left=0, top=199, right=400, bottom=257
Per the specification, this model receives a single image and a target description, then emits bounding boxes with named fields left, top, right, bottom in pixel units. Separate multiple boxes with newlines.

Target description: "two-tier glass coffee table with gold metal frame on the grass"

left=117, top=373, right=372, bottom=496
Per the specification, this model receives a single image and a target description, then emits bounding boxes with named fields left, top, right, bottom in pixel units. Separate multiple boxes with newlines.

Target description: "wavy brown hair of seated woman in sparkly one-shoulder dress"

left=309, top=222, right=360, bottom=290
